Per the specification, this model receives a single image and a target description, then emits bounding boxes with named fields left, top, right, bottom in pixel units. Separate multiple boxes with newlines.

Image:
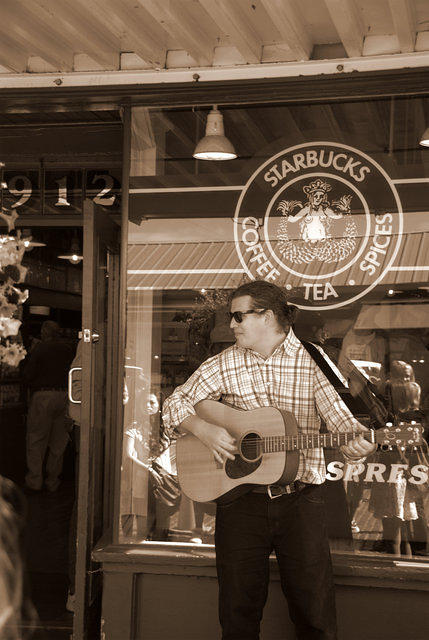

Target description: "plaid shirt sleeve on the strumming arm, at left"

left=162, top=356, right=221, bottom=434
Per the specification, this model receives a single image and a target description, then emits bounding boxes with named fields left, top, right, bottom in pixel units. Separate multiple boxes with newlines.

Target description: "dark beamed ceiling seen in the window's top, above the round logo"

left=125, top=96, right=429, bottom=196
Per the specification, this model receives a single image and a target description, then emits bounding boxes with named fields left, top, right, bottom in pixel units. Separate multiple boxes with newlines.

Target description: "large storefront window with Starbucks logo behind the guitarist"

left=119, top=96, right=429, bottom=561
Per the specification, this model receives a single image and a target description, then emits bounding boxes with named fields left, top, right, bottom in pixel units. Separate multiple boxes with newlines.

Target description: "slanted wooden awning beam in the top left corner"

left=0, top=0, right=74, bottom=71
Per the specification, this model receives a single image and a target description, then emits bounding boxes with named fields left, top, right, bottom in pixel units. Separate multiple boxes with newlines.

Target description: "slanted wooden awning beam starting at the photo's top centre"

left=199, top=0, right=262, bottom=64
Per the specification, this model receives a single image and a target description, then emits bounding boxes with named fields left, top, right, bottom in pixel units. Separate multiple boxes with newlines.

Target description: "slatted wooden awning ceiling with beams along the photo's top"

left=0, top=0, right=429, bottom=75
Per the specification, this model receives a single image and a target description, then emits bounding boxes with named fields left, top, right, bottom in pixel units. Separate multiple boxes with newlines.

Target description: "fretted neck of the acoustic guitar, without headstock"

left=259, top=431, right=373, bottom=453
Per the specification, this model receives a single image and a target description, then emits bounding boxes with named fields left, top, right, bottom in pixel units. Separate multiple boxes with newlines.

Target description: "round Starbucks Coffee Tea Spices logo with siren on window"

left=234, top=142, right=403, bottom=309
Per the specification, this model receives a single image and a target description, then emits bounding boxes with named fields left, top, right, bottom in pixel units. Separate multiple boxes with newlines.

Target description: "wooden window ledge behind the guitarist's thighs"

left=92, top=540, right=429, bottom=591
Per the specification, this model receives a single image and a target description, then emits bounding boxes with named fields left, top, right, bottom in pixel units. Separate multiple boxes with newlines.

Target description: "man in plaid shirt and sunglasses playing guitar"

left=163, top=280, right=375, bottom=640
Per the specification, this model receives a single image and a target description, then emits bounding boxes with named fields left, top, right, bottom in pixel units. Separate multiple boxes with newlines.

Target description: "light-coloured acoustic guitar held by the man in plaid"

left=177, top=400, right=423, bottom=504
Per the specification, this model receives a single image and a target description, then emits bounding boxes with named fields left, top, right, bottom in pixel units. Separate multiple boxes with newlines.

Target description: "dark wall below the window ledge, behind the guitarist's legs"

left=103, top=567, right=429, bottom=640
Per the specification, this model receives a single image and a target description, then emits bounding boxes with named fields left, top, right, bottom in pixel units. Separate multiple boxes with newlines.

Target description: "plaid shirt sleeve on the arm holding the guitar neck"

left=314, top=366, right=362, bottom=433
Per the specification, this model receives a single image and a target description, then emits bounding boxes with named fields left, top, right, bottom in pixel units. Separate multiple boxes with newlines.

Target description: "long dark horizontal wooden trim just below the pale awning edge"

left=0, top=67, right=429, bottom=113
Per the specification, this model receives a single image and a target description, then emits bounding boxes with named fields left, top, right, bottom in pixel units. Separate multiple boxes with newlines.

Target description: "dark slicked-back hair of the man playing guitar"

left=231, top=280, right=298, bottom=329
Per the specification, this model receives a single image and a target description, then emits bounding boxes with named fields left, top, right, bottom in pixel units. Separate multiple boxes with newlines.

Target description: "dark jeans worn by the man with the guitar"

left=216, top=485, right=337, bottom=640
